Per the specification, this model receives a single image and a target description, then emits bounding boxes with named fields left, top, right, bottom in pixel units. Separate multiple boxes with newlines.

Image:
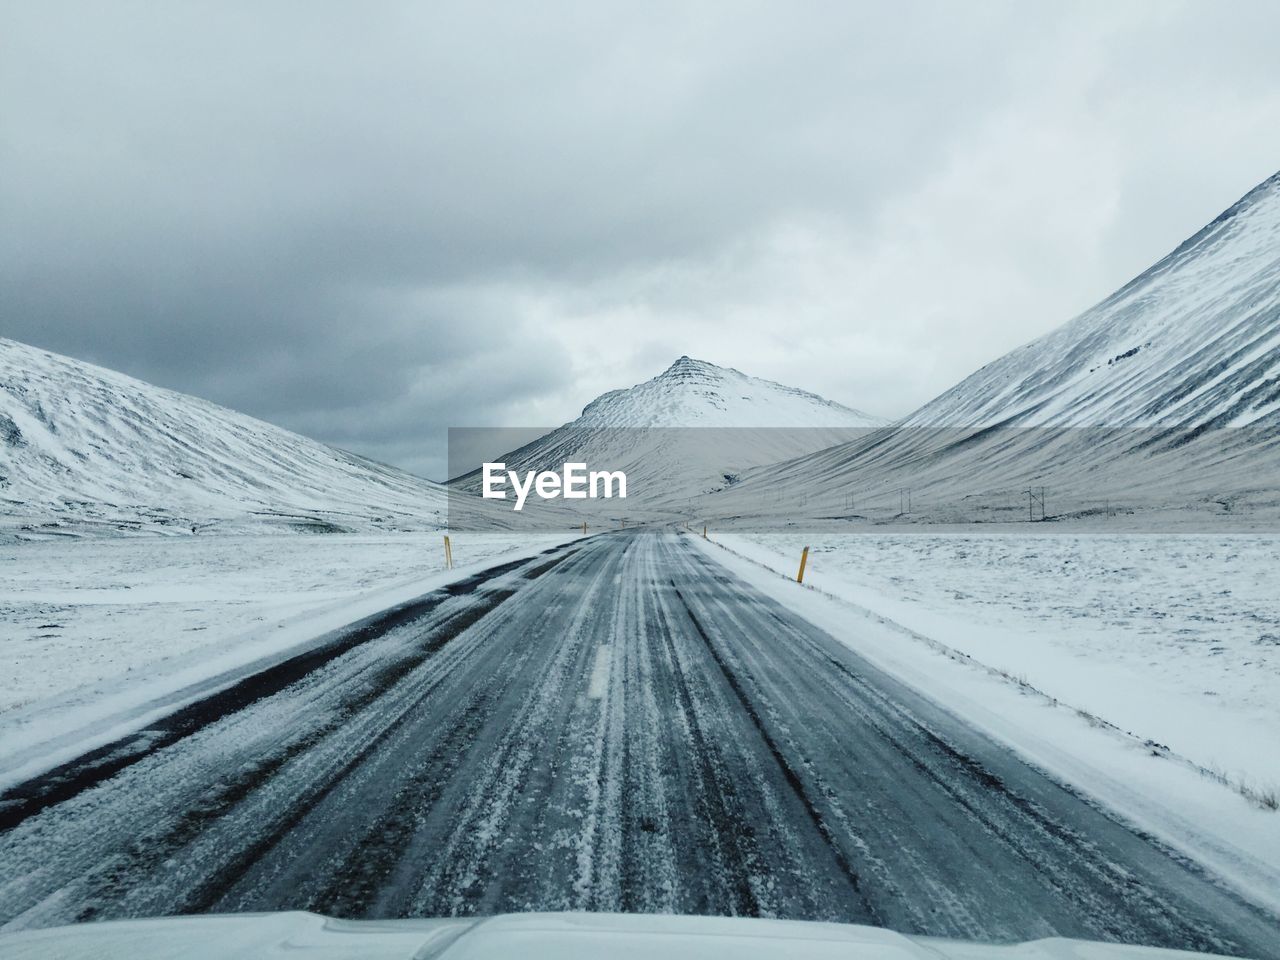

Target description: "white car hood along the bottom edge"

left=0, top=913, right=1228, bottom=960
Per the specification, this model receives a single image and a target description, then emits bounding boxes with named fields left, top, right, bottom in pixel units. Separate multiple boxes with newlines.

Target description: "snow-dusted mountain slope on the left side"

left=0, top=338, right=445, bottom=534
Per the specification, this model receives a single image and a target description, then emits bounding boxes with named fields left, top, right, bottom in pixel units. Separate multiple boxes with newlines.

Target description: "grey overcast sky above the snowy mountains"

left=0, top=0, right=1280, bottom=479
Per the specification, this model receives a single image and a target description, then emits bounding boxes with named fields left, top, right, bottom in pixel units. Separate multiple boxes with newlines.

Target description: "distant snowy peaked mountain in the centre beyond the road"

left=454, top=357, right=888, bottom=516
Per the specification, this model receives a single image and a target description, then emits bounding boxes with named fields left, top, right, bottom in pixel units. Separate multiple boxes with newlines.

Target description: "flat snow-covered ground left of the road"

left=0, top=532, right=572, bottom=783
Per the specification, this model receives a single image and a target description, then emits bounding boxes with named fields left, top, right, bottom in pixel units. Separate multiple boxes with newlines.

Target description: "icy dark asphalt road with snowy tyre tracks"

left=0, top=531, right=1280, bottom=957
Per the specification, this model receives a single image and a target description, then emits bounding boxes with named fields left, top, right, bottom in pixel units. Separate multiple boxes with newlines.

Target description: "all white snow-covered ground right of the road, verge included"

left=690, top=530, right=1280, bottom=910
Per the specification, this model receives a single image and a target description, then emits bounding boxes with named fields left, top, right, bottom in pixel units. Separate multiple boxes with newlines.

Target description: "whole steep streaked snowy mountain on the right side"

left=717, top=168, right=1280, bottom=520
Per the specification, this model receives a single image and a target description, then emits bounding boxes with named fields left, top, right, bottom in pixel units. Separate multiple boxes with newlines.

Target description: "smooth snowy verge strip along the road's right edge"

left=685, top=535, right=1280, bottom=914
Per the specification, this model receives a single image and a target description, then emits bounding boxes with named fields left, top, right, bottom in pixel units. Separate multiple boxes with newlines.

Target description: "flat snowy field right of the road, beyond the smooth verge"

left=716, top=532, right=1280, bottom=796
